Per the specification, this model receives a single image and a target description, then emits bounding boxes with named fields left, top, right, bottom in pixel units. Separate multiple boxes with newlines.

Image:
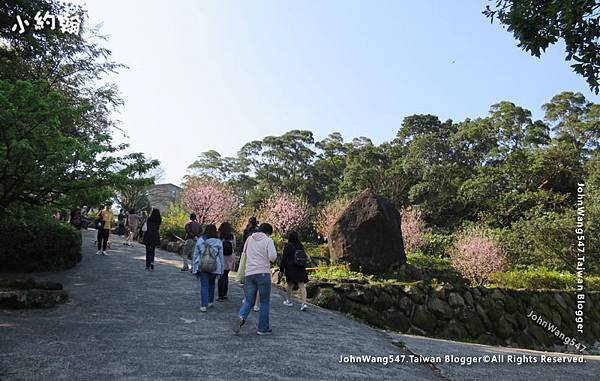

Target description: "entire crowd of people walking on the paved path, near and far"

left=71, top=204, right=309, bottom=335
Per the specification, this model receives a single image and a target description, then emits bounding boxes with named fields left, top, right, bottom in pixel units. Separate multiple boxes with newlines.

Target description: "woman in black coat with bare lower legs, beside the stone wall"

left=279, top=230, right=308, bottom=311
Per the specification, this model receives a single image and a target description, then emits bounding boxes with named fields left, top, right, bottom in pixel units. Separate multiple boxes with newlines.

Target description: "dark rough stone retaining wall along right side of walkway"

left=307, top=281, right=600, bottom=352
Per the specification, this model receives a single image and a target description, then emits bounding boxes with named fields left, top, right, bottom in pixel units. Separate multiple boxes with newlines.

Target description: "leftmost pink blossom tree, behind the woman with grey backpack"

left=181, top=178, right=238, bottom=224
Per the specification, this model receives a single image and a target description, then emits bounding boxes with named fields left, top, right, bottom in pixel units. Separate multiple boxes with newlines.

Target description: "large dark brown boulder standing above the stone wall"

left=329, top=189, right=406, bottom=274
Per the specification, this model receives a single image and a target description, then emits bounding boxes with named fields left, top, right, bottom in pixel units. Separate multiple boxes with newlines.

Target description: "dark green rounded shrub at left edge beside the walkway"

left=0, top=217, right=81, bottom=272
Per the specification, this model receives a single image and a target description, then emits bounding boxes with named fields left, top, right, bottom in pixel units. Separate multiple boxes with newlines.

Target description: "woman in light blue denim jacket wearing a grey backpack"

left=192, top=225, right=223, bottom=312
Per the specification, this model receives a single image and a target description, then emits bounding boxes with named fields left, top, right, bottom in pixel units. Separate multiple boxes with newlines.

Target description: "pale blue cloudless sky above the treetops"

left=80, top=0, right=599, bottom=184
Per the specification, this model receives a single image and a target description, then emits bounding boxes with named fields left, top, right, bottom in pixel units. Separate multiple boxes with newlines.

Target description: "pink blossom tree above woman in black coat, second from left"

left=259, top=192, right=309, bottom=234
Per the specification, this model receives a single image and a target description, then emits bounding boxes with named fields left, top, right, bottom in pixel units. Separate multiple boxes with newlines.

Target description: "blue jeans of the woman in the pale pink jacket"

left=240, top=273, right=271, bottom=332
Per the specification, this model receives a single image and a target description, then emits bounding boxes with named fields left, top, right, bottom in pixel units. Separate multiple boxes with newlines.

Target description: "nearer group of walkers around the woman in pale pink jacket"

left=181, top=213, right=308, bottom=335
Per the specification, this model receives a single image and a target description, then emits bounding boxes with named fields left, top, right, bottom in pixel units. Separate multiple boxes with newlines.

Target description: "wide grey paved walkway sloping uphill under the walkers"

left=0, top=230, right=600, bottom=381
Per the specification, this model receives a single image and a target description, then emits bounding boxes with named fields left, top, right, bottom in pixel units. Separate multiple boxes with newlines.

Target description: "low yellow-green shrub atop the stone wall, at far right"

left=490, top=267, right=600, bottom=291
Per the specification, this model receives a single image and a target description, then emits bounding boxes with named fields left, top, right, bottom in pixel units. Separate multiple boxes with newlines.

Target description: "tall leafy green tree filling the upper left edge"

left=0, top=0, right=158, bottom=214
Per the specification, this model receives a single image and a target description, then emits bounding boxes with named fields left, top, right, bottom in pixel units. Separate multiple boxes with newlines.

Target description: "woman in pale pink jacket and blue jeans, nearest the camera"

left=233, top=224, right=277, bottom=335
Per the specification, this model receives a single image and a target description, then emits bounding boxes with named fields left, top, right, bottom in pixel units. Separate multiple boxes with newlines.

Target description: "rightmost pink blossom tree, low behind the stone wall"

left=450, top=229, right=504, bottom=286
